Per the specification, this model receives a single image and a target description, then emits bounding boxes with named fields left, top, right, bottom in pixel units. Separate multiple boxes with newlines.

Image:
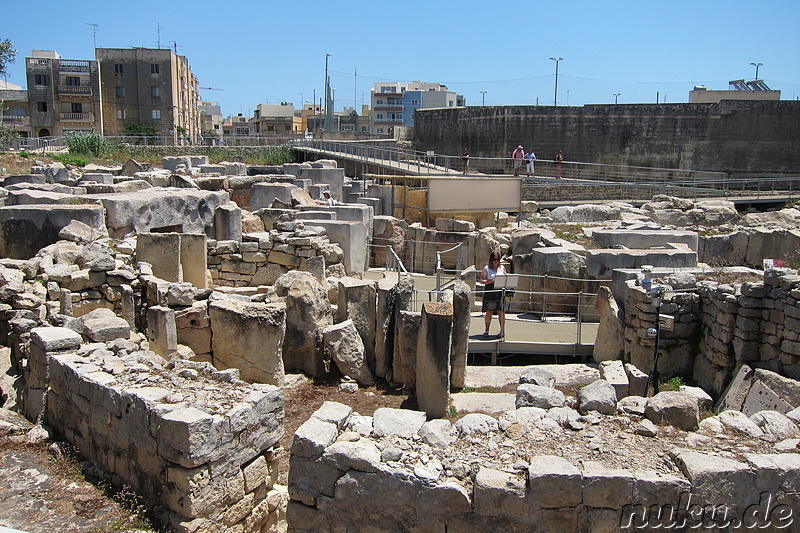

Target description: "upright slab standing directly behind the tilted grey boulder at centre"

left=336, top=277, right=377, bottom=370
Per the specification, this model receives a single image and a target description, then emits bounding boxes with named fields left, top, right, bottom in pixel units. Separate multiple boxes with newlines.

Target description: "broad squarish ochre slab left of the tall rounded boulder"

left=209, top=300, right=286, bottom=387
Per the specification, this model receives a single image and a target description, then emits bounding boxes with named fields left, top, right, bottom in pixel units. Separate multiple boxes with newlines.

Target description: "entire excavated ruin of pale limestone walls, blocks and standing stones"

left=0, top=156, right=800, bottom=531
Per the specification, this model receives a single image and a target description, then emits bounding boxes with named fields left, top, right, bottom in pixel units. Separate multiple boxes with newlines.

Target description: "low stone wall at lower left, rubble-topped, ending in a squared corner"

left=31, top=327, right=285, bottom=532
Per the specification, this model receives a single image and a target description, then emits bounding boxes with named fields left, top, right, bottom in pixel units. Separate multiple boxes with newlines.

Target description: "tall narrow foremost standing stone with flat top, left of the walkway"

left=416, top=302, right=453, bottom=418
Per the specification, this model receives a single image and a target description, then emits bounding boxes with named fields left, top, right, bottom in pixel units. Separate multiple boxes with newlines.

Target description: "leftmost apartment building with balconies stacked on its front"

left=24, top=50, right=103, bottom=137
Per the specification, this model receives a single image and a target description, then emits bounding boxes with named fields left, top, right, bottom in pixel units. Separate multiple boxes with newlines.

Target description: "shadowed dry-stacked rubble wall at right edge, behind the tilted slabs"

left=611, top=269, right=800, bottom=397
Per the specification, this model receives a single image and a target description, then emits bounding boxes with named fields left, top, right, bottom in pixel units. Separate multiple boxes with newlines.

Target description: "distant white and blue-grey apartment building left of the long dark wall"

left=370, top=81, right=467, bottom=136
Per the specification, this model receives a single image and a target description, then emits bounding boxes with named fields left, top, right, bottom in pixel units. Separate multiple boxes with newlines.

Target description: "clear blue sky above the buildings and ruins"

left=0, top=0, right=800, bottom=115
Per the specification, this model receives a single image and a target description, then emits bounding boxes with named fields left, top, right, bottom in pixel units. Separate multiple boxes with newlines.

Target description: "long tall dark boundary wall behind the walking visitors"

left=414, top=101, right=800, bottom=177
